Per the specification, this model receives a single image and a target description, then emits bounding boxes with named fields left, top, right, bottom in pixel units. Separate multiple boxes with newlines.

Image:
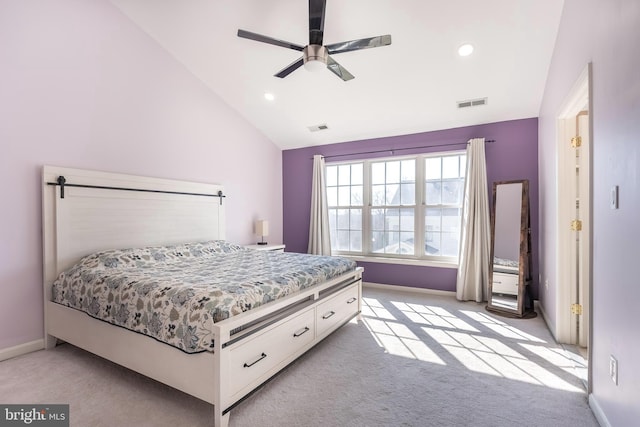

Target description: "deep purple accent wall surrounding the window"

left=282, top=118, right=538, bottom=298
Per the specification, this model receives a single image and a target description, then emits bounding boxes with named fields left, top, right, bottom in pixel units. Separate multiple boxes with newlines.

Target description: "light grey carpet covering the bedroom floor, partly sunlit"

left=0, top=288, right=598, bottom=427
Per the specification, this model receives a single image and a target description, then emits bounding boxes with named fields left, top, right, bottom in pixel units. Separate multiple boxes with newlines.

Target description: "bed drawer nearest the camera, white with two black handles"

left=229, top=308, right=315, bottom=397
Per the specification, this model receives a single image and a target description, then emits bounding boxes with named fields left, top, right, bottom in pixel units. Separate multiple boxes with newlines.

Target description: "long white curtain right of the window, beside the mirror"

left=456, top=138, right=491, bottom=302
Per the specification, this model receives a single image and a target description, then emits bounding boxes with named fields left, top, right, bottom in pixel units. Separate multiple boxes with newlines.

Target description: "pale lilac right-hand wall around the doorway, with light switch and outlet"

left=539, top=0, right=640, bottom=426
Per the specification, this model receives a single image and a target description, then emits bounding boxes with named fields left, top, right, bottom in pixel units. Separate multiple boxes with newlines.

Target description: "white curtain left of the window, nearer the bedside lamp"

left=308, top=154, right=331, bottom=255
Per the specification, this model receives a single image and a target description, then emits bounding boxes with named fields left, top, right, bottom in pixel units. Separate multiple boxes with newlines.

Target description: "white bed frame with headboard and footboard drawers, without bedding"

left=42, top=166, right=362, bottom=427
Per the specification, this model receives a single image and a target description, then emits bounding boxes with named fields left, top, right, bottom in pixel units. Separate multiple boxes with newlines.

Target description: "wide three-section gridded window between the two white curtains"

left=326, top=153, right=466, bottom=261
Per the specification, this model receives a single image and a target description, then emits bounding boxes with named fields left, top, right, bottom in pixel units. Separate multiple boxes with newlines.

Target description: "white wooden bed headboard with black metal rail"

left=42, top=166, right=225, bottom=294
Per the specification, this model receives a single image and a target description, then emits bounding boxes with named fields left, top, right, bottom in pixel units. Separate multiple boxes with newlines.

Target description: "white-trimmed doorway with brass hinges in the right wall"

left=556, top=64, right=592, bottom=383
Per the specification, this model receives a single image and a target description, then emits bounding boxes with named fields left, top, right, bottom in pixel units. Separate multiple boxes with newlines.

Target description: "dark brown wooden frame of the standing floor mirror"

left=487, top=179, right=535, bottom=317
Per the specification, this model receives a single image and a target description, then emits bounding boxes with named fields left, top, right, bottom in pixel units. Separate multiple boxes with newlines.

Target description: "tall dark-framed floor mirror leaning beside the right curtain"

left=487, top=179, right=536, bottom=317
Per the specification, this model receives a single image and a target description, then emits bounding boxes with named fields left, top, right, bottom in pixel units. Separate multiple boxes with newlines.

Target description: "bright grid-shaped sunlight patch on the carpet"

left=362, top=298, right=584, bottom=393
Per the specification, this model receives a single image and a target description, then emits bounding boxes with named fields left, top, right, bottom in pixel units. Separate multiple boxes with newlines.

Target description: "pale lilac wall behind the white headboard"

left=0, top=0, right=282, bottom=351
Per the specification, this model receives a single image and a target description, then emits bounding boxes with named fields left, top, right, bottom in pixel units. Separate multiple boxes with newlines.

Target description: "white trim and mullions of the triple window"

left=325, top=150, right=466, bottom=269
